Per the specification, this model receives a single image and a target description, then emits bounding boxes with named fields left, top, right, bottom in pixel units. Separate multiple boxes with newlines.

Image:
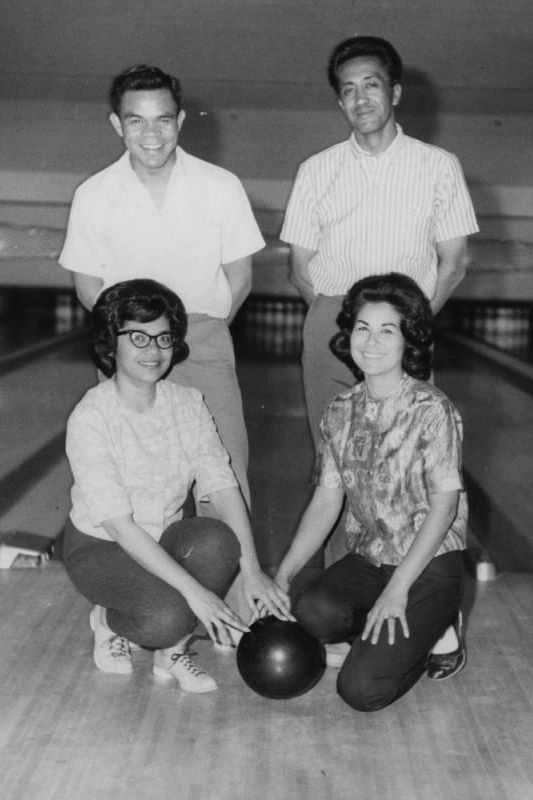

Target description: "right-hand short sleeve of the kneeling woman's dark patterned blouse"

left=420, top=401, right=463, bottom=494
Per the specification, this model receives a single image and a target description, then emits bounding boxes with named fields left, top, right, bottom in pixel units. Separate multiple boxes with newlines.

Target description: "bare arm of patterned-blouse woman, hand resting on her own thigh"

left=361, top=491, right=459, bottom=644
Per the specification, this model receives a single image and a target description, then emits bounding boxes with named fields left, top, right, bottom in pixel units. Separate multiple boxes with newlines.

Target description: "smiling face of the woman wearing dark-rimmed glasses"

left=115, top=315, right=173, bottom=388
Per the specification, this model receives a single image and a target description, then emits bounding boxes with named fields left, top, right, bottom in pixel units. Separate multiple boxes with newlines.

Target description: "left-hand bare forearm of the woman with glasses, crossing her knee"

left=102, top=515, right=248, bottom=643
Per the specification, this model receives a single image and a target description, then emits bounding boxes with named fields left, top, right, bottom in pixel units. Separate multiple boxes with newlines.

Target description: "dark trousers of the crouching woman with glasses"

left=63, top=517, right=240, bottom=649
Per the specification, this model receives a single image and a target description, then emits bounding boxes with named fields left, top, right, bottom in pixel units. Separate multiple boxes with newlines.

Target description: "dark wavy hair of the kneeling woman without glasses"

left=330, top=272, right=433, bottom=380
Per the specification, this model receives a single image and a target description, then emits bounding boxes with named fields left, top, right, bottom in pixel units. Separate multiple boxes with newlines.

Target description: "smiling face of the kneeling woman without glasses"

left=350, top=303, right=405, bottom=391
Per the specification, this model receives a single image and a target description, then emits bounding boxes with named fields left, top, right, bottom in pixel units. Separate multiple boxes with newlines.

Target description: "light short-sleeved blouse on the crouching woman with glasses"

left=66, top=378, right=237, bottom=540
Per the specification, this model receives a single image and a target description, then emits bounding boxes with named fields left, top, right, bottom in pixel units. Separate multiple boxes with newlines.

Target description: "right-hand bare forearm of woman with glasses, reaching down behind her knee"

left=209, top=486, right=292, bottom=619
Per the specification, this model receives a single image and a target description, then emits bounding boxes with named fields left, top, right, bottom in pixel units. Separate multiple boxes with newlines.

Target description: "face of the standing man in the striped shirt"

left=338, top=56, right=402, bottom=149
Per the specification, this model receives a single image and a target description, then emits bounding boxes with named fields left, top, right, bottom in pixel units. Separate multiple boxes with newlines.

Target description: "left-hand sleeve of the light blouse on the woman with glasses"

left=66, top=406, right=133, bottom=526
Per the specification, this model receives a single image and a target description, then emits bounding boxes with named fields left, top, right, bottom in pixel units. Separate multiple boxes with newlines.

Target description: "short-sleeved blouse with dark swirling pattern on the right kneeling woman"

left=317, top=375, right=467, bottom=566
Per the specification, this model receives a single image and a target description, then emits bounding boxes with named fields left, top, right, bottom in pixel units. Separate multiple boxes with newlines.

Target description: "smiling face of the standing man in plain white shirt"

left=109, top=89, right=185, bottom=177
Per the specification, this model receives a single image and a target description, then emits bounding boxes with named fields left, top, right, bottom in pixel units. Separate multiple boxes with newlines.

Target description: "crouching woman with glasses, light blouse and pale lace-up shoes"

left=63, top=280, right=290, bottom=692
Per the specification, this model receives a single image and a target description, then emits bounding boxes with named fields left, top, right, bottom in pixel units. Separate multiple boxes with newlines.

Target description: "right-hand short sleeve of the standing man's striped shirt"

left=434, top=154, right=479, bottom=242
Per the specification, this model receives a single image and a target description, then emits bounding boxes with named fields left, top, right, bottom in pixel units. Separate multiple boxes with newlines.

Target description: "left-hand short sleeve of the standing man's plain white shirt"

left=59, top=187, right=107, bottom=278
